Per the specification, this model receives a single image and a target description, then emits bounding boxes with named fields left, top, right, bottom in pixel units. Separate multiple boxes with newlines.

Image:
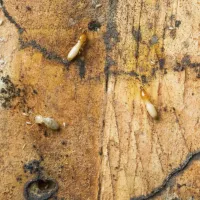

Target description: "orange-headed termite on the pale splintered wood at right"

left=140, top=86, right=158, bottom=119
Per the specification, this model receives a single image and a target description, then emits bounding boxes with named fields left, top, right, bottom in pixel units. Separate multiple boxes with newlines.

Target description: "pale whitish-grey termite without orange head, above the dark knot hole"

left=35, top=115, right=60, bottom=130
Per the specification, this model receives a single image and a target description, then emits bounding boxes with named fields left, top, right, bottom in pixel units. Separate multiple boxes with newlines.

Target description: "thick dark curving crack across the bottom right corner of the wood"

left=130, top=150, right=200, bottom=200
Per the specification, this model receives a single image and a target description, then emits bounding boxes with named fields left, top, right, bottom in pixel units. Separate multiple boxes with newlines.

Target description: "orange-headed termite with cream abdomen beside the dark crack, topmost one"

left=67, top=32, right=87, bottom=61
